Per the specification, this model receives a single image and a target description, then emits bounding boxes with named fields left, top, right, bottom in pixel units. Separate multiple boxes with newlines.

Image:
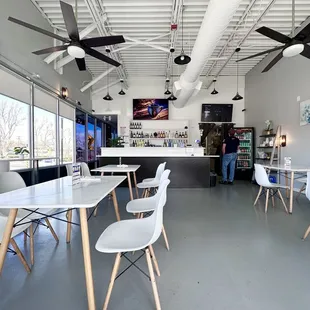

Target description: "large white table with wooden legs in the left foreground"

left=0, top=176, right=126, bottom=310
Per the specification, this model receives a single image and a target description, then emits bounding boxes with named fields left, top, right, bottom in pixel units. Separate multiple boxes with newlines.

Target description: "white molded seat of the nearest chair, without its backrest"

left=96, top=217, right=153, bottom=253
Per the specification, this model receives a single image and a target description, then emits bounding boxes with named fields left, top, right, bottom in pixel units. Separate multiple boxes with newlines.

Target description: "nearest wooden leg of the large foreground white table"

left=80, top=208, right=96, bottom=310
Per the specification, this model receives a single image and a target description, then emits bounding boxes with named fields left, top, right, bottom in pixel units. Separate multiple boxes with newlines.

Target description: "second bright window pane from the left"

left=34, top=107, right=56, bottom=166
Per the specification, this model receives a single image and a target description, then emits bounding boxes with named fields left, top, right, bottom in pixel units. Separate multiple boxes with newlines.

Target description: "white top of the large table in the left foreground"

left=0, top=176, right=126, bottom=209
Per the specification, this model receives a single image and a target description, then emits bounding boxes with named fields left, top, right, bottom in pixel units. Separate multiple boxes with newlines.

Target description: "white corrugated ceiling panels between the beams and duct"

left=29, top=0, right=310, bottom=88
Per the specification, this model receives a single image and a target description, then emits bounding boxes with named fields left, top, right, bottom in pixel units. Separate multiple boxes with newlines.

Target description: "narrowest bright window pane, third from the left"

left=59, top=117, right=73, bottom=164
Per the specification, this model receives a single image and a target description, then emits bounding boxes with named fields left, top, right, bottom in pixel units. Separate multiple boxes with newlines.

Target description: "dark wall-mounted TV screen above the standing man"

left=201, top=103, right=233, bottom=123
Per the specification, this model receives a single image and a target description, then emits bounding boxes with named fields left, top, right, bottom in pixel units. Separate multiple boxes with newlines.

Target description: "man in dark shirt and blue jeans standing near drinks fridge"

left=220, top=128, right=240, bottom=185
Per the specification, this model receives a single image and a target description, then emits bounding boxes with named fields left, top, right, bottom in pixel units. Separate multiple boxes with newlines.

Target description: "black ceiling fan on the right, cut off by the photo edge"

left=238, top=0, right=310, bottom=72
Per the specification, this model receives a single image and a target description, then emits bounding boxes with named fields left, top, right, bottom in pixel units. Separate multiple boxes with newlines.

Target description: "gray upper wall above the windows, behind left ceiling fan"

left=0, top=0, right=92, bottom=112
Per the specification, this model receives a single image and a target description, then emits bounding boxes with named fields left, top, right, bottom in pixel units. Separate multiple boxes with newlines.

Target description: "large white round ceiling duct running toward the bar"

left=173, top=0, right=242, bottom=108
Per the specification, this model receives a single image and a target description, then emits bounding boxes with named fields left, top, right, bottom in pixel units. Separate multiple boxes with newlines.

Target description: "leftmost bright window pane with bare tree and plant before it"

left=0, top=94, right=30, bottom=170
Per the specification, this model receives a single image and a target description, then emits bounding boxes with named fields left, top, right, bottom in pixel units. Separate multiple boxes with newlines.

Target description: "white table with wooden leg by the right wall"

left=263, top=164, right=310, bottom=214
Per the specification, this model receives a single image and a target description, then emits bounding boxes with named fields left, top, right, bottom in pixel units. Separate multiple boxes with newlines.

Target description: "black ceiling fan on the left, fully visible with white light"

left=8, top=1, right=125, bottom=71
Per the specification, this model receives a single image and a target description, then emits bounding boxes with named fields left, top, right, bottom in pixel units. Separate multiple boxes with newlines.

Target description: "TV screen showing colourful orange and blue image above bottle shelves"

left=133, top=99, right=169, bottom=120
